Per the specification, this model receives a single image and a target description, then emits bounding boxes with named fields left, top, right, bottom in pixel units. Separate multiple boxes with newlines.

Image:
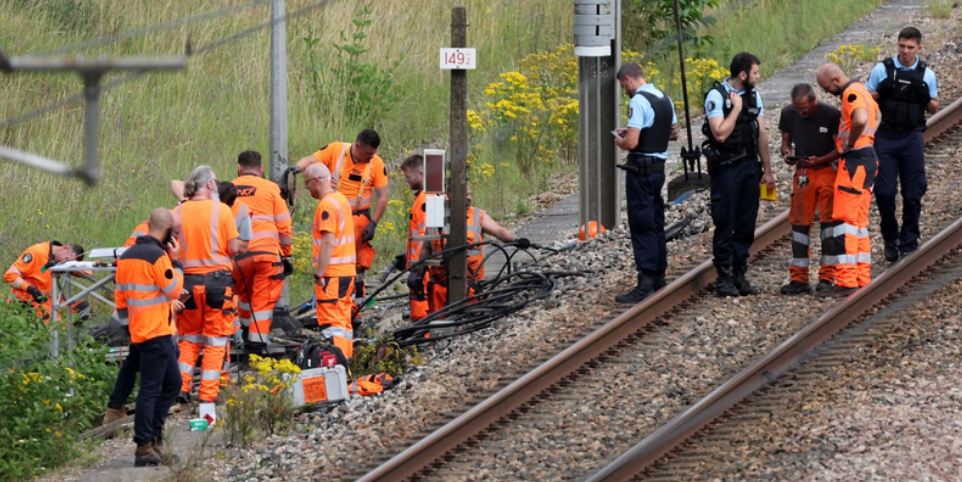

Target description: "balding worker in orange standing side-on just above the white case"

left=304, top=164, right=356, bottom=359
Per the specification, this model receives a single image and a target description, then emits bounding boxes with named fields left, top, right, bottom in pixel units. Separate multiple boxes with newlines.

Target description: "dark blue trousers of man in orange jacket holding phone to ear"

left=134, top=335, right=182, bottom=445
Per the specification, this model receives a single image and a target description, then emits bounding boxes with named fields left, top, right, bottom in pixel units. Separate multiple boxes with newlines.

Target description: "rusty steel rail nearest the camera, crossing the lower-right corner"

left=584, top=94, right=962, bottom=482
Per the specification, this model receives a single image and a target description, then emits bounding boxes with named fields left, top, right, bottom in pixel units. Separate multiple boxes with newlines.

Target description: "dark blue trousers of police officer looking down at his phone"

left=625, top=172, right=668, bottom=275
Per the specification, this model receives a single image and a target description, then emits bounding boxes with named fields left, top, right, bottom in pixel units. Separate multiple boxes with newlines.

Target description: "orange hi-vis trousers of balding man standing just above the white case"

left=314, top=276, right=354, bottom=359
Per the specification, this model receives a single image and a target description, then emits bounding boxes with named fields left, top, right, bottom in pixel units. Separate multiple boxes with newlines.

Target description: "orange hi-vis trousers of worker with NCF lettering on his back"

left=234, top=252, right=284, bottom=343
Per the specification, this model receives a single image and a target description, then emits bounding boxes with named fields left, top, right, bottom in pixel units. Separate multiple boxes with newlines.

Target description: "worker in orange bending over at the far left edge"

left=3, top=241, right=90, bottom=323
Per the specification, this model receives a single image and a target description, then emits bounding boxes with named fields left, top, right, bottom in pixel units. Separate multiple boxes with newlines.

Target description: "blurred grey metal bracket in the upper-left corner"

left=0, top=50, right=187, bottom=186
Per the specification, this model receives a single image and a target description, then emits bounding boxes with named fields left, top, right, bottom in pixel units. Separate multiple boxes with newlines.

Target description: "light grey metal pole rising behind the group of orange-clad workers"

left=270, top=0, right=291, bottom=311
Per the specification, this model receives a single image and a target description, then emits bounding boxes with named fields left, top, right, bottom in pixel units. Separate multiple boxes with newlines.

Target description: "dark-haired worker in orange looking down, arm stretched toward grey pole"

left=284, top=129, right=388, bottom=302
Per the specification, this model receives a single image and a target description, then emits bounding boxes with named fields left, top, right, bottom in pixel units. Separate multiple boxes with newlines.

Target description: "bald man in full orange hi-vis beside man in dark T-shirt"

left=817, top=64, right=882, bottom=297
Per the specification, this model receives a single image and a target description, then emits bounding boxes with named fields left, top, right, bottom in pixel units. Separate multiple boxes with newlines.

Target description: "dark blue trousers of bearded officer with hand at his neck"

left=711, top=159, right=762, bottom=266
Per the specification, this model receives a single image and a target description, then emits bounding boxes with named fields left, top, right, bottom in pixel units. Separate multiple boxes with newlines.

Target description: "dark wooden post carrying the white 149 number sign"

left=447, top=5, right=468, bottom=304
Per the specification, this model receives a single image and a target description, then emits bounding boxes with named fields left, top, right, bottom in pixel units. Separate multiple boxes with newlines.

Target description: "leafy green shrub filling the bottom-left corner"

left=0, top=303, right=117, bottom=480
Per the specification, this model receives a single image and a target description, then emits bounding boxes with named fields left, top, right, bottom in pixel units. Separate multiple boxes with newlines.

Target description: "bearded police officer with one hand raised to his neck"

left=702, top=52, right=775, bottom=296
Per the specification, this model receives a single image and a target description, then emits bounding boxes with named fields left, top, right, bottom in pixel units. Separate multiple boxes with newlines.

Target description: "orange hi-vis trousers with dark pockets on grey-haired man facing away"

left=177, top=271, right=237, bottom=402
